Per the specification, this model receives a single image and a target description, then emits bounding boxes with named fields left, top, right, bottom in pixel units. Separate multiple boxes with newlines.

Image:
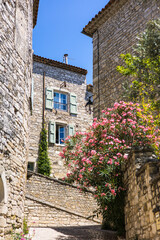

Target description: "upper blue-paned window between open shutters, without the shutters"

left=54, top=92, right=68, bottom=111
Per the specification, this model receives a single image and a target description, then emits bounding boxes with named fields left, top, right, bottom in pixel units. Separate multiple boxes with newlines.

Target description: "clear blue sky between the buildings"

left=33, top=0, right=108, bottom=84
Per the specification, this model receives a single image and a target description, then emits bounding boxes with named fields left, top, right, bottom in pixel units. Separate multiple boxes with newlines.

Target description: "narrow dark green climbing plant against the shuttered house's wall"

left=38, top=128, right=51, bottom=176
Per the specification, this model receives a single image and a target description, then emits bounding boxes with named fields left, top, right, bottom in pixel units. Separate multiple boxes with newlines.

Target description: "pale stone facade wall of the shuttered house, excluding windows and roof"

left=29, top=62, right=92, bottom=178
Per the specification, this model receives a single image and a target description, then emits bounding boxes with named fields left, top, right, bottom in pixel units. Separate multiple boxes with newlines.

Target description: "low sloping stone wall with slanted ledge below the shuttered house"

left=25, top=172, right=100, bottom=227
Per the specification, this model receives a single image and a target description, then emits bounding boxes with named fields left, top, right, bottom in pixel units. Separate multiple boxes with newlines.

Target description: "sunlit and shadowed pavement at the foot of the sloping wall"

left=30, top=226, right=117, bottom=240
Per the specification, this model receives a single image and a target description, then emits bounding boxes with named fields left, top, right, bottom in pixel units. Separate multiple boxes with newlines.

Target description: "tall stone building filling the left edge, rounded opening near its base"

left=0, top=0, right=39, bottom=239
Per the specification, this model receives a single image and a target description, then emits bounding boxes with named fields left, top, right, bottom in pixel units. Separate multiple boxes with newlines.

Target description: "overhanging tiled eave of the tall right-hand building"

left=82, top=0, right=121, bottom=37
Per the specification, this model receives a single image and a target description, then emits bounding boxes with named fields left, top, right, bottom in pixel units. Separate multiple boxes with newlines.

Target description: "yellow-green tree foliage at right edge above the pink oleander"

left=117, top=19, right=160, bottom=112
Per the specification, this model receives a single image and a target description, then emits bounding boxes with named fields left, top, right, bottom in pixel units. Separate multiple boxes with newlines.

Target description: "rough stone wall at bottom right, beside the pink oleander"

left=124, top=152, right=160, bottom=240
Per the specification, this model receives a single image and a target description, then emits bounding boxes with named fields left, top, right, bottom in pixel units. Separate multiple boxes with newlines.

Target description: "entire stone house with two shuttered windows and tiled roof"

left=29, top=55, right=92, bottom=178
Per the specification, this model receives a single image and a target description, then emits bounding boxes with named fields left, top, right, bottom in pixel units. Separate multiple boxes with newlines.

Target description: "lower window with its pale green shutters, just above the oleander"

left=48, top=122, right=74, bottom=145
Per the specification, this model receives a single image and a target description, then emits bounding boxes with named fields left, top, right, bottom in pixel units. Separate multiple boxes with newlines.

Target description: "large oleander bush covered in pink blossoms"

left=60, top=101, right=160, bottom=234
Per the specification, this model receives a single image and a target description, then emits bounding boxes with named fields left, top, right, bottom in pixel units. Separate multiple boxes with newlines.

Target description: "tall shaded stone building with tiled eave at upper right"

left=82, top=0, right=160, bottom=117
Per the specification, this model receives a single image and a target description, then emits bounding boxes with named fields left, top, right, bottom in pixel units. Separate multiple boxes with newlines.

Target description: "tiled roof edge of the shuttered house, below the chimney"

left=33, top=55, right=87, bottom=75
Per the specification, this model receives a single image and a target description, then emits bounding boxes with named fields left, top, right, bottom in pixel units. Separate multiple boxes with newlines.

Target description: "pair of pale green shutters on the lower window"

left=48, top=121, right=74, bottom=143
